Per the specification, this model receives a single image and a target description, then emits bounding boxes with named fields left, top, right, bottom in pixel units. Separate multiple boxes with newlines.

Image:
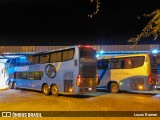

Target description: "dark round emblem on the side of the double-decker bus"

left=45, top=64, right=56, bottom=79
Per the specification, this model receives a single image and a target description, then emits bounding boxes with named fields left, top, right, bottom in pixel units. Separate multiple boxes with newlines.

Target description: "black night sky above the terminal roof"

left=0, top=0, right=160, bottom=45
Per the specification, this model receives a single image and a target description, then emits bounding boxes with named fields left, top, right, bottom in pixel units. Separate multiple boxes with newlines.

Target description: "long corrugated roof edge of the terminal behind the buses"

left=0, top=44, right=160, bottom=55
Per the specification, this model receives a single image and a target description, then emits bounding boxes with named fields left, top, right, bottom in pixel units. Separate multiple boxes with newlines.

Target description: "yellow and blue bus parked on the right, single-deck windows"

left=97, top=53, right=158, bottom=93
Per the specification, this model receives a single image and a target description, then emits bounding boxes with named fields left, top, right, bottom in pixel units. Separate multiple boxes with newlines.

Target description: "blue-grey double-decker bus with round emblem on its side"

left=9, top=46, right=98, bottom=96
